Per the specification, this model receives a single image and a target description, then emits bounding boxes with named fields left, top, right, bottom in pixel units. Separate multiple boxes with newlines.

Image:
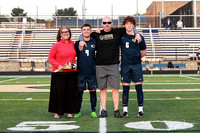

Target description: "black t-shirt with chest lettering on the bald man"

left=91, top=28, right=126, bottom=65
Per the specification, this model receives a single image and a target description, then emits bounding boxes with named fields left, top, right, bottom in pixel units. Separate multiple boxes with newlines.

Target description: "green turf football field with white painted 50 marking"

left=0, top=75, right=200, bottom=133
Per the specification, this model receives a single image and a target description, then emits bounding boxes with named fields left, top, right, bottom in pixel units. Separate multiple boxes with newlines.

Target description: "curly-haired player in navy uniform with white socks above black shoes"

left=120, top=16, right=146, bottom=118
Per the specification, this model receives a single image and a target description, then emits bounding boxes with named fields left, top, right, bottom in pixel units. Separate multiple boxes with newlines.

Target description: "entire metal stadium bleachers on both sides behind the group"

left=0, top=28, right=200, bottom=71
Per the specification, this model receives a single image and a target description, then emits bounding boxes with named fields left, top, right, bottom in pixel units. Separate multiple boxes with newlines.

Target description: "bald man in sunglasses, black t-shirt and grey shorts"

left=79, top=17, right=141, bottom=118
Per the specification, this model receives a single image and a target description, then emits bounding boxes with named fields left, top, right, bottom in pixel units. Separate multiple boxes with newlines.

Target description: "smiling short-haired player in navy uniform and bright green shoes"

left=74, top=24, right=97, bottom=118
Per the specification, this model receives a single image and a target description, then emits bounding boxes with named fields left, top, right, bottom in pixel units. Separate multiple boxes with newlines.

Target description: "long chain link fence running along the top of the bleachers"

left=0, top=15, right=200, bottom=29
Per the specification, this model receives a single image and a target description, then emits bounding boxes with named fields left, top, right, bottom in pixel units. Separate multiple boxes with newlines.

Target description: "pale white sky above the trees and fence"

left=0, top=0, right=194, bottom=18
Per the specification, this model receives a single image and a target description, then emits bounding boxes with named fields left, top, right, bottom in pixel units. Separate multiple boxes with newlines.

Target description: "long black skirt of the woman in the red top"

left=49, top=71, right=79, bottom=115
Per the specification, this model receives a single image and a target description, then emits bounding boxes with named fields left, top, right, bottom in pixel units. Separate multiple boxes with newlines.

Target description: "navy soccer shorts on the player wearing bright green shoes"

left=78, top=75, right=97, bottom=91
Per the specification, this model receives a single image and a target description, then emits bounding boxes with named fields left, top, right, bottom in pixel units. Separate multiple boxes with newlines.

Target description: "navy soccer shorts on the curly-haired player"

left=121, top=64, right=143, bottom=83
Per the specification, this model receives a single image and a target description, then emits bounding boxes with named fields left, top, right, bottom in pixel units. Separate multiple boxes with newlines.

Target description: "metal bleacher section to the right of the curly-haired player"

left=142, top=29, right=200, bottom=61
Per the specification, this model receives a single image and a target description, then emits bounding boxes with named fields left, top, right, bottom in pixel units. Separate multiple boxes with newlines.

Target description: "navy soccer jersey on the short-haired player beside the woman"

left=75, top=39, right=97, bottom=75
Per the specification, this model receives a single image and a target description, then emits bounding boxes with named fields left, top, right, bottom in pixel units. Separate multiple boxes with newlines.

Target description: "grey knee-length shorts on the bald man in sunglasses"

left=96, top=64, right=120, bottom=89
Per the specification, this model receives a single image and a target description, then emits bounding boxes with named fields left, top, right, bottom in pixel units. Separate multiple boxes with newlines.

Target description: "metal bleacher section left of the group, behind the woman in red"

left=0, top=29, right=81, bottom=61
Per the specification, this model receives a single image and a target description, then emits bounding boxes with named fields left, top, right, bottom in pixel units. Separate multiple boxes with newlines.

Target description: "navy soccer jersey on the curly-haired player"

left=120, top=33, right=146, bottom=65
